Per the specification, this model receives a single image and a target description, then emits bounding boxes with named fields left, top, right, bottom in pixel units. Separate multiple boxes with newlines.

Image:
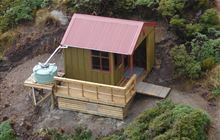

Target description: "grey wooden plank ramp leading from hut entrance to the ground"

left=136, top=82, right=171, bottom=98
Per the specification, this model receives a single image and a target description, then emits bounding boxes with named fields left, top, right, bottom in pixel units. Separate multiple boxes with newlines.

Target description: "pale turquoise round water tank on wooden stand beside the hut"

left=33, top=63, right=57, bottom=84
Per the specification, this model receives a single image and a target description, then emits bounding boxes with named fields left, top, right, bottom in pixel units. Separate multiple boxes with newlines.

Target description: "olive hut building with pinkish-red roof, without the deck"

left=61, top=14, right=156, bottom=86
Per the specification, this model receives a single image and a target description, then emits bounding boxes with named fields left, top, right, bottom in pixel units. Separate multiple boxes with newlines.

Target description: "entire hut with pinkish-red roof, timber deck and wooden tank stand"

left=25, top=14, right=156, bottom=119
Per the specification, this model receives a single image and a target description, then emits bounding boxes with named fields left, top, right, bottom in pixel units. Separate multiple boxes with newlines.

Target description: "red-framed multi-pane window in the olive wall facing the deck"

left=92, top=51, right=109, bottom=71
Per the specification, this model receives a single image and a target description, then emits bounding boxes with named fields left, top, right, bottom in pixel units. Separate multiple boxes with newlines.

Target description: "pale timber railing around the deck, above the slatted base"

left=54, top=75, right=136, bottom=106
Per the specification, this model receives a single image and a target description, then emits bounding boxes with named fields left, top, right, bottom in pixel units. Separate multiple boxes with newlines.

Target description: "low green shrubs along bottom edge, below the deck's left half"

left=38, top=127, right=92, bottom=140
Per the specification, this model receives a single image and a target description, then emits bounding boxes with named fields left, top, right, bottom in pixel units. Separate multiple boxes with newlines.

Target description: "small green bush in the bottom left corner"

left=0, top=121, right=17, bottom=140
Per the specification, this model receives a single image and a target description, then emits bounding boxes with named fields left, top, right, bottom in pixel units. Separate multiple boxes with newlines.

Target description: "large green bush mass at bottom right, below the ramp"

left=101, top=100, right=210, bottom=140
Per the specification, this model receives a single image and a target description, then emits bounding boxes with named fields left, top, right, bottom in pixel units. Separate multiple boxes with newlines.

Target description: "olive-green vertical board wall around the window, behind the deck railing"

left=64, top=47, right=114, bottom=85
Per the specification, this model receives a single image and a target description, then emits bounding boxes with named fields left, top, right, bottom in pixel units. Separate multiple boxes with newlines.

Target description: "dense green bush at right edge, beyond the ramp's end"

left=170, top=33, right=220, bottom=79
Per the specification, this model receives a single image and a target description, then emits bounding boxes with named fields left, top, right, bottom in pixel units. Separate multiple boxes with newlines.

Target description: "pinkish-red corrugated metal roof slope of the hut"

left=61, top=14, right=155, bottom=55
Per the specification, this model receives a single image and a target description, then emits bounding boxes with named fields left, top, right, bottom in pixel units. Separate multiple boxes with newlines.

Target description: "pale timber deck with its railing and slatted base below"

left=54, top=75, right=136, bottom=120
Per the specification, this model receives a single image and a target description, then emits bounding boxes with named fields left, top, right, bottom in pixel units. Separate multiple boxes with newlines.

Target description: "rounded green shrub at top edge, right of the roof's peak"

left=159, top=0, right=185, bottom=17
